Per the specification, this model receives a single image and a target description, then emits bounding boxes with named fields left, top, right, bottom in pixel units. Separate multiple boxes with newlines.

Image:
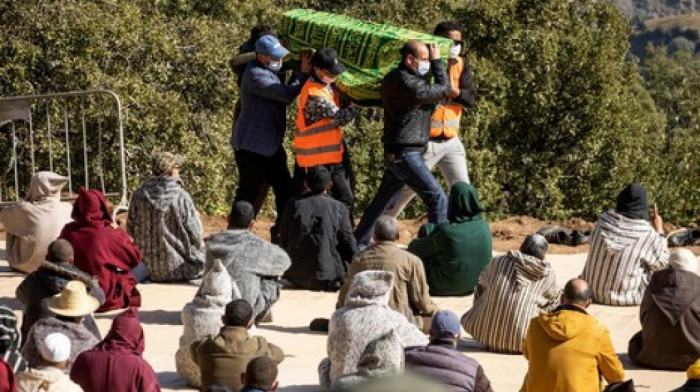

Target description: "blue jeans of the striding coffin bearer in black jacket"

left=355, top=151, right=447, bottom=246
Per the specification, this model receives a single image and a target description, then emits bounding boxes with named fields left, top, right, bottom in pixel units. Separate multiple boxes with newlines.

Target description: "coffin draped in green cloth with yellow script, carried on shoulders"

left=281, top=9, right=452, bottom=105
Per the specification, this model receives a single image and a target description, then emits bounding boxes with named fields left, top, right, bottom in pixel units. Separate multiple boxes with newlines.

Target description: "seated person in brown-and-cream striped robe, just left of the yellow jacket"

left=461, top=234, right=559, bottom=353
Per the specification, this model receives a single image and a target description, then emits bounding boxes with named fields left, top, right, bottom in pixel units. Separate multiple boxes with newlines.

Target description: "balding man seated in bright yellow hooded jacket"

left=520, top=279, right=625, bottom=392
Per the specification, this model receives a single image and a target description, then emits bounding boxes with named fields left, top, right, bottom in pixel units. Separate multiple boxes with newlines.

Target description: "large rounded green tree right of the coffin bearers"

left=458, top=0, right=663, bottom=219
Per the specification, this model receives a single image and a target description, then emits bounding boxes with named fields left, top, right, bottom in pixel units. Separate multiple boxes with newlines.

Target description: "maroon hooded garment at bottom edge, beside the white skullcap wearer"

left=70, top=308, right=160, bottom=392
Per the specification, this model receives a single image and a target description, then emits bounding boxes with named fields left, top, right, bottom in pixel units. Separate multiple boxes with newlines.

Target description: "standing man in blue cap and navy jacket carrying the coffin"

left=231, top=35, right=311, bottom=242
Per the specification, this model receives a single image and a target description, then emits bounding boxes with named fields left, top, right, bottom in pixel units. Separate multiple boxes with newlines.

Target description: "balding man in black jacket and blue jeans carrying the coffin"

left=355, top=40, right=451, bottom=247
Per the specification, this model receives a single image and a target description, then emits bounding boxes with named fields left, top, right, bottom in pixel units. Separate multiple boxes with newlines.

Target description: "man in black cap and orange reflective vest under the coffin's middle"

left=294, top=48, right=357, bottom=216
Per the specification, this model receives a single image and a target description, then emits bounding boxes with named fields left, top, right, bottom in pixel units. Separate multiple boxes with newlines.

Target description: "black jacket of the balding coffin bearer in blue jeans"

left=381, top=60, right=451, bottom=153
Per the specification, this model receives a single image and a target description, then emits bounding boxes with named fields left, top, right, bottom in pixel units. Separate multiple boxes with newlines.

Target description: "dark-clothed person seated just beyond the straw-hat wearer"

left=15, top=240, right=105, bottom=339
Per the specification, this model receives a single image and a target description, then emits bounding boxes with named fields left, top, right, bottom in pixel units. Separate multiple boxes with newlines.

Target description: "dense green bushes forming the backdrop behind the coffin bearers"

left=0, top=0, right=698, bottom=227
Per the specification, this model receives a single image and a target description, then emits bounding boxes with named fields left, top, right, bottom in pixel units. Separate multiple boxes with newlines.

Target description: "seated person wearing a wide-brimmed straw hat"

left=22, top=280, right=100, bottom=368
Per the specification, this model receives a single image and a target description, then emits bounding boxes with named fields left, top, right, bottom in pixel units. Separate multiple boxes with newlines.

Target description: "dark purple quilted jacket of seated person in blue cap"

left=405, top=340, right=493, bottom=392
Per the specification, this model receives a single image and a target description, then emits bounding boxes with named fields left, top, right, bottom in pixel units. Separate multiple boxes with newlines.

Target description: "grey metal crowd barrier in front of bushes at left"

left=0, top=90, right=129, bottom=215
